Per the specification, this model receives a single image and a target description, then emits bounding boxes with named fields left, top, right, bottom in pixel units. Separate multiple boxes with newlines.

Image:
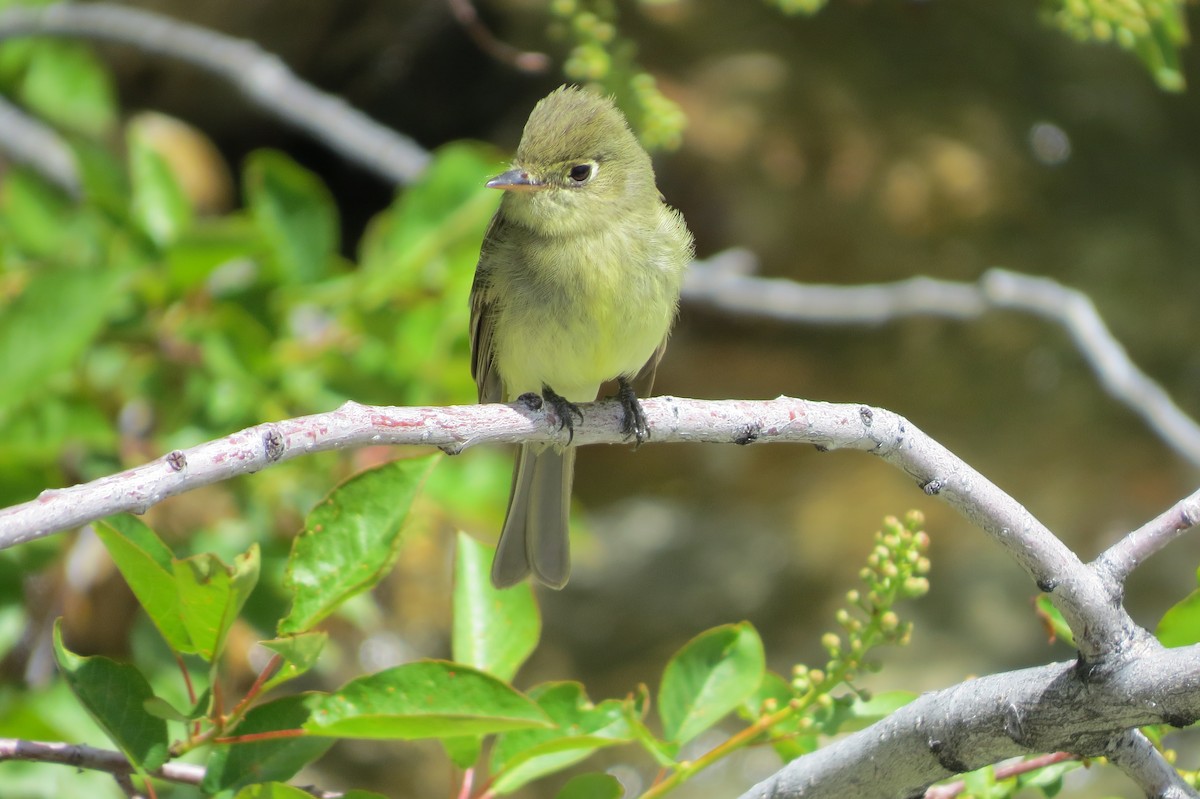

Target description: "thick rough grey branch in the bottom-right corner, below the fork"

left=743, top=641, right=1200, bottom=799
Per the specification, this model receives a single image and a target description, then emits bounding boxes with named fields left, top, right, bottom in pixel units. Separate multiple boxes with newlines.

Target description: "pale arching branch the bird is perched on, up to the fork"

left=0, top=397, right=1171, bottom=660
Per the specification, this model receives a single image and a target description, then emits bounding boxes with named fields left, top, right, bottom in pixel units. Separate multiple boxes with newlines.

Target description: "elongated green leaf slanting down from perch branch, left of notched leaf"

left=95, top=515, right=196, bottom=654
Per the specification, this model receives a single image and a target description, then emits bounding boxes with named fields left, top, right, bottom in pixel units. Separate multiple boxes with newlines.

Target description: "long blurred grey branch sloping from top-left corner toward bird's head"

left=0, top=2, right=430, bottom=184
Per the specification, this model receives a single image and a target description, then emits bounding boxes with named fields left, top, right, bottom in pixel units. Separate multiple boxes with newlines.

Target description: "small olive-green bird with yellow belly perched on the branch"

left=470, top=86, right=692, bottom=588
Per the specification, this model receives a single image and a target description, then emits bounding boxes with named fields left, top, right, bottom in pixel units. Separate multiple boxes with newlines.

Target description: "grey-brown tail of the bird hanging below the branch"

left=492, top=444, right=575, bottom=589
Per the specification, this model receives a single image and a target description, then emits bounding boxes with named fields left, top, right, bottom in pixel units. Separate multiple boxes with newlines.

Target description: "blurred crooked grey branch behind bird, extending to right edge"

left=683, top=250, right=1200, bottom=465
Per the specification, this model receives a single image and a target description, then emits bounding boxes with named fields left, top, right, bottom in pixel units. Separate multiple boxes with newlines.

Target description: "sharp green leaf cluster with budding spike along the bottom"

left=21, top=456, right=929, bottom=799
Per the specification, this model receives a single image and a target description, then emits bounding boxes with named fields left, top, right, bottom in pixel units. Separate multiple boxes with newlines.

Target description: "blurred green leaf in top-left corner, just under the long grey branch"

left=19, top=41, right=116, bottom=137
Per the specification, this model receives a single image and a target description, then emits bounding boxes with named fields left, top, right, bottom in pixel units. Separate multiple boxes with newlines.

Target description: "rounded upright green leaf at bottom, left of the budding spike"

left=659, top=621, right=766, bottom=744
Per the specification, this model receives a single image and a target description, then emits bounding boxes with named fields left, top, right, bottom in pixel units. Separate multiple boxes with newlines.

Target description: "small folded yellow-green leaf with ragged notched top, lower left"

left=175, top=543, right=259, bottom=662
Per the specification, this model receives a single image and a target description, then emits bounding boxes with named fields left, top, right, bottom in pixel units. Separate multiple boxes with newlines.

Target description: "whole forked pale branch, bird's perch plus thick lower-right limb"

left=0, top=396, right=1200, bottom=798
